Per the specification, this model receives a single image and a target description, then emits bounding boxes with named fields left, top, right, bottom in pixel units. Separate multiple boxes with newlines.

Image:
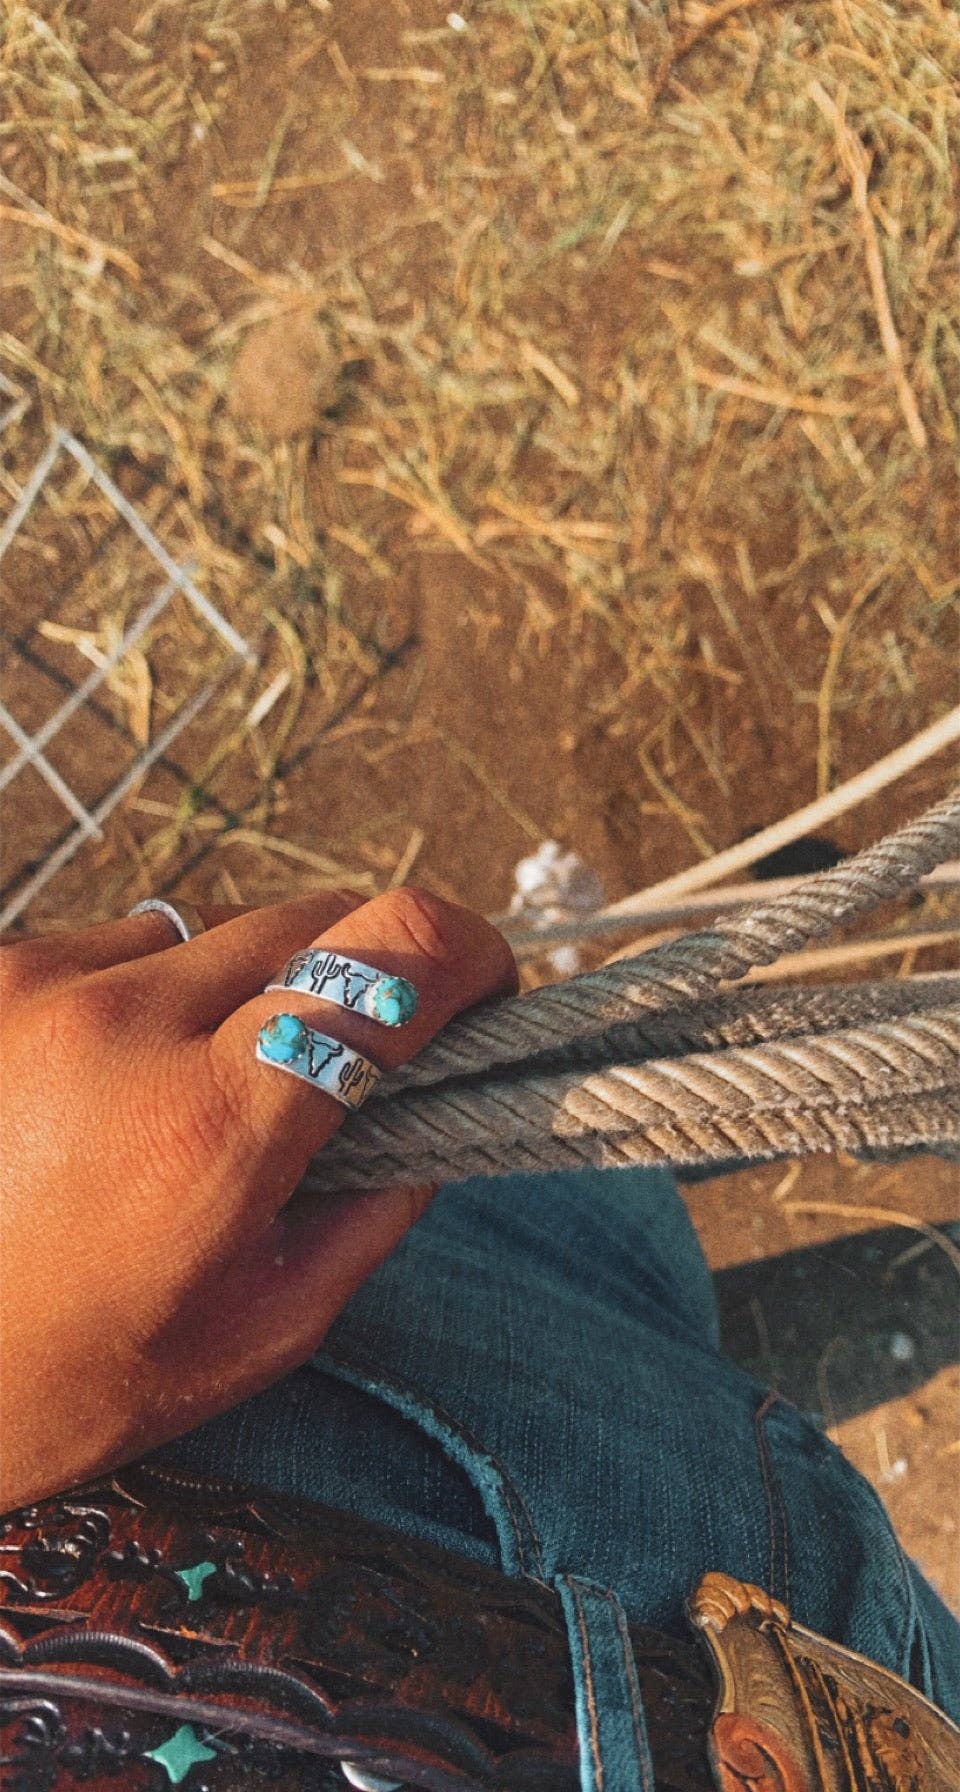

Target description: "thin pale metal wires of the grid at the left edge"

left=0, top=431, right=256, bottom=928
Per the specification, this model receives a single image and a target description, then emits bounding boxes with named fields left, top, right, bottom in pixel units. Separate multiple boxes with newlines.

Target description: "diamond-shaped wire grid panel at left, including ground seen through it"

left=0, top=428, right=256, bottom=928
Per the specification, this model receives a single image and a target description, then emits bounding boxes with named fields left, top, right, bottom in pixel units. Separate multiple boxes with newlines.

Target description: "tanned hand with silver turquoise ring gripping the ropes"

left=0, top=889, right=518, bottom=1511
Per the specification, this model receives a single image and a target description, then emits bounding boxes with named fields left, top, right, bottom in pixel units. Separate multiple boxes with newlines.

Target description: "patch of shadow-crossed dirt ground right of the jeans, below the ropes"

left=684, top=1158, right=960, bottom=1613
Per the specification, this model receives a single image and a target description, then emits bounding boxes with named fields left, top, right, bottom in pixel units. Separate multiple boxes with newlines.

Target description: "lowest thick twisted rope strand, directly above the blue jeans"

left=310, top=1004, right=960, bottom=1190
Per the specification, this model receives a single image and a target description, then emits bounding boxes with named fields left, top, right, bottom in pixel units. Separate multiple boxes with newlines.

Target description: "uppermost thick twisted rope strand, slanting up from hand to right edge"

left=380, top=792, right=960, bottom=1095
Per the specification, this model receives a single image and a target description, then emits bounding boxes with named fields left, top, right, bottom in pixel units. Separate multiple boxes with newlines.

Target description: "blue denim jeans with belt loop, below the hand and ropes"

left=158, top=1170, right=960, bottom=1792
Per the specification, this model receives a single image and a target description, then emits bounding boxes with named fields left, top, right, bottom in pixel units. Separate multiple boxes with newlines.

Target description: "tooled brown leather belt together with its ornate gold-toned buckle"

left=0, top=1466, right=960, bottom=1792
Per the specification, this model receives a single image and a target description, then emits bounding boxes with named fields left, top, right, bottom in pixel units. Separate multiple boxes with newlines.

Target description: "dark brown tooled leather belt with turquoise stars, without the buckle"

left=0, top=1468, right=713, bottom=1792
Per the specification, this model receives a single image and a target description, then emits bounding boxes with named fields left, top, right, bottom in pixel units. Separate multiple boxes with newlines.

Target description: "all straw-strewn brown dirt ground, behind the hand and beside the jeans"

left=0, top=0, right=960, bottom=1611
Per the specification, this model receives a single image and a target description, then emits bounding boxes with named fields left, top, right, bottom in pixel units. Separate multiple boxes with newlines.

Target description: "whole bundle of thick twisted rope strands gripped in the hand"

left=304, top=794, right=960, bottom=1193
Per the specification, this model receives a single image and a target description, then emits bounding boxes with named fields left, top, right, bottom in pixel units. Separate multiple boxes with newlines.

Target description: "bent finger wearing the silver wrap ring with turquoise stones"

left=183, top=889, right=518, bottom=1215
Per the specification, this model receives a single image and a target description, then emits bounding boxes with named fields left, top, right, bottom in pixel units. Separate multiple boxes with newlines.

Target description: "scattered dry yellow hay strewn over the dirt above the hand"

left=0, top=0, right=960, bottom=924
